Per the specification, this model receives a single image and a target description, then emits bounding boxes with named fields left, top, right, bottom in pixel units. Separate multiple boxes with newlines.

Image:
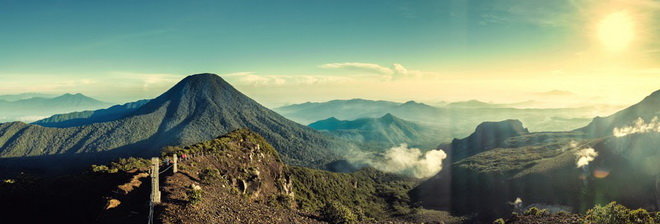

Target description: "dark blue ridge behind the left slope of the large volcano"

left=32, top=100, right=149, bottom=128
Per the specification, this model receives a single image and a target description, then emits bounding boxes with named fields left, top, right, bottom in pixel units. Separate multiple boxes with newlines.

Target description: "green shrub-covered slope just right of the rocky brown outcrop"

left=290, top=167, right=416, bottom=221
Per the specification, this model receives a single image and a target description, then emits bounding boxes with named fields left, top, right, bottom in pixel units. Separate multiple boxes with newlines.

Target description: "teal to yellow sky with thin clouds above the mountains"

left=0, top=0, right=660, bottom=107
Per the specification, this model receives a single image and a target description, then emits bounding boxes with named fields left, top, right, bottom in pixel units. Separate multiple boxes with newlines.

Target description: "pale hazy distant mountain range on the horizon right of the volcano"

left=274, top=99, right=618, bottom=138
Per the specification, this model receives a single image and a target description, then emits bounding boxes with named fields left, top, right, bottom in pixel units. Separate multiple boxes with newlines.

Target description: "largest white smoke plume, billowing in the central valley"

left=365, top=144, right=447, bottom=178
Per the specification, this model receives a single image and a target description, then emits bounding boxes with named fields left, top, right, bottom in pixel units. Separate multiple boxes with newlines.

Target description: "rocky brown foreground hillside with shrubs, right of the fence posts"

left=159, top=129, right=459, bottom=223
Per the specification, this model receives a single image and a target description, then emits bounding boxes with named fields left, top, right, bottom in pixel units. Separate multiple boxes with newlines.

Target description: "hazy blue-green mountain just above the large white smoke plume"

left=309, top=113, right=448, bottom=150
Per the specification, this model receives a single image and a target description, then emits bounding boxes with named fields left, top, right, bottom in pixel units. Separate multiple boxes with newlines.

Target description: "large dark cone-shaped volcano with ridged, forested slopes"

left=0, top=74, right=347, bottom=171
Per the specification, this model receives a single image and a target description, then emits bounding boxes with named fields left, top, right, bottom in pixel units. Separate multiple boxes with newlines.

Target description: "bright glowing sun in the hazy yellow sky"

left=598, top=11, right=635, bottom=52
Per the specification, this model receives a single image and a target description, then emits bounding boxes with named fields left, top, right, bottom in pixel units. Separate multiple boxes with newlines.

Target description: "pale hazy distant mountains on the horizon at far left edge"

left=0, top=93, right=112, bottom=122
